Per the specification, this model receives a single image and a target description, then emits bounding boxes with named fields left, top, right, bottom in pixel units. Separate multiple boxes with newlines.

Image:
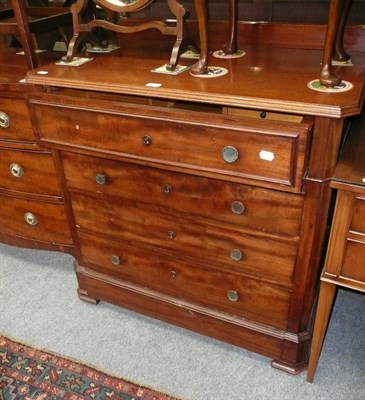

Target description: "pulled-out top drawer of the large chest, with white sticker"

left=30, top=96, right=311, bottom=191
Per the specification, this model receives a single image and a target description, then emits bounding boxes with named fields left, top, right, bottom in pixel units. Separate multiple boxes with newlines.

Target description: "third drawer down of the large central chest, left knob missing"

left=71, top=194, right=297, bottom=286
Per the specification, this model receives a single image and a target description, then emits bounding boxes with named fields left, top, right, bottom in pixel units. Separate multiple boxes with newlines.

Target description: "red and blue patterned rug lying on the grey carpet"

left=0, top=334, right=182, bottom=400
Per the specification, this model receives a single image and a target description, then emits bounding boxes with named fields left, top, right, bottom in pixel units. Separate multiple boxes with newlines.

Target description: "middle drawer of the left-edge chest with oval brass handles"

left=0, top=149, right=60, bottom=196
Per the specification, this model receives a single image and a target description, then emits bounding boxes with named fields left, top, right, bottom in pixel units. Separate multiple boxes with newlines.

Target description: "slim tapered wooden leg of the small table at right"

left=307, top=281, right=337, bottom=382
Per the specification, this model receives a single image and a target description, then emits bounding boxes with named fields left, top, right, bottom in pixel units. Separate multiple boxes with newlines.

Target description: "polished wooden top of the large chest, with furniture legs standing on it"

left=27, top=41, right=365, bottom=118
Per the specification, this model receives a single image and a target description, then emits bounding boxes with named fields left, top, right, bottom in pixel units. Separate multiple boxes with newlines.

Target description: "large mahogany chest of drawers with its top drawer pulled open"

left=28, top=42, right=364, bottom=373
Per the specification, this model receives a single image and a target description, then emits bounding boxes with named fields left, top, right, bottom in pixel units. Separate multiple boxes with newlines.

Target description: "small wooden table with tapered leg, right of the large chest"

left=307, top=113, right=365, bottom=382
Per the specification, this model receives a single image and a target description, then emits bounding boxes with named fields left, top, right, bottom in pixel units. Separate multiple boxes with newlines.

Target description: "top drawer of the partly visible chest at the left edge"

left=0, top=98, right=35, bottom=142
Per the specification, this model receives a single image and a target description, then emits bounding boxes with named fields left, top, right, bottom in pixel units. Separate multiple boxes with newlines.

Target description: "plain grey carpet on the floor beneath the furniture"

left=0, top=244, right=365, bottom=400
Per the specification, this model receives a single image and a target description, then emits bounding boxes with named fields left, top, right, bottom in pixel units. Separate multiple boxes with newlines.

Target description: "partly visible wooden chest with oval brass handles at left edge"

left=0, top=57, right=73, bottom=252
